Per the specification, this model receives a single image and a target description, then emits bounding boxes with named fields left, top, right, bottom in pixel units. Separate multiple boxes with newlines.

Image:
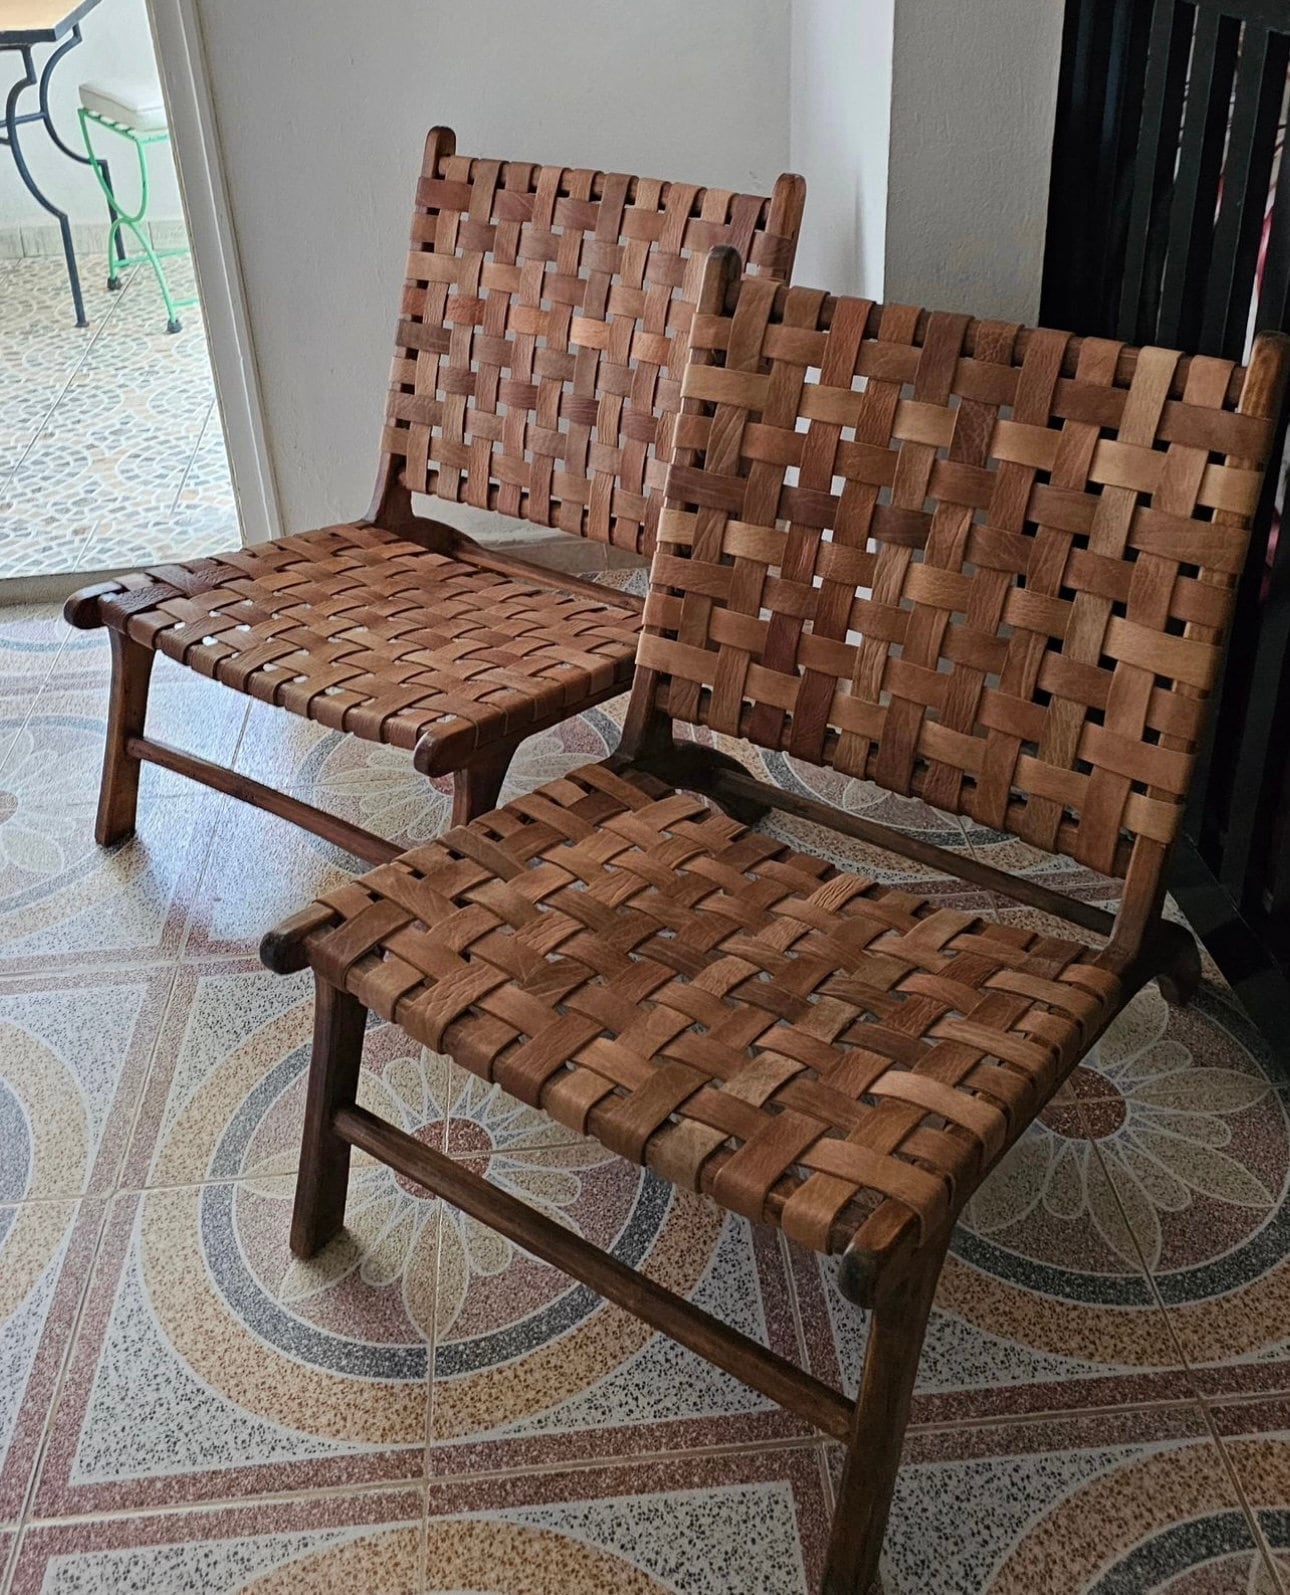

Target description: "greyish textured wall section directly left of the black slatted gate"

left=880, top=0, right=1062, bottom=321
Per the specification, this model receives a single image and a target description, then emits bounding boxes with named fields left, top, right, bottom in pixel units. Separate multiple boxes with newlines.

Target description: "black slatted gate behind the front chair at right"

left=1041, top=0, right=1290, bottom=1048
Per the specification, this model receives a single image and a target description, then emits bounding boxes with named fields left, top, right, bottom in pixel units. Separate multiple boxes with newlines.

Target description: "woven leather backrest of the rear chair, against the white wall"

left=383, top=128, right=805, bottom=552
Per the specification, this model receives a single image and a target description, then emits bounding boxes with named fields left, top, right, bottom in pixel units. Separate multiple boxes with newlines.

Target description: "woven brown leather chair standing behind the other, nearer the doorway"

left=64, top=128, right=805, bottom=863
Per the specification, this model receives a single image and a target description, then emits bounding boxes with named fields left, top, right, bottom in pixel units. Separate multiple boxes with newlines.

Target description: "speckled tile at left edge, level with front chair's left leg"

left=0, top=965, right=172, bottom=1201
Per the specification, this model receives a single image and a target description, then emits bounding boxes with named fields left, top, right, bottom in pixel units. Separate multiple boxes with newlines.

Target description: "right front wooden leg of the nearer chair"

left=820, top=1239, right=949, bottom=1595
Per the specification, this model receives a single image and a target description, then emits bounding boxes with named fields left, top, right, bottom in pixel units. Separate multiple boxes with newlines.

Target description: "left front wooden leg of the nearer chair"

left=290, top=976, right=367, bottom=1257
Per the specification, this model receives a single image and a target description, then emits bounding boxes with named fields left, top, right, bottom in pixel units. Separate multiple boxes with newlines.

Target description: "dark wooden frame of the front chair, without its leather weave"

left=262, top=252, right=1290, bottom=1595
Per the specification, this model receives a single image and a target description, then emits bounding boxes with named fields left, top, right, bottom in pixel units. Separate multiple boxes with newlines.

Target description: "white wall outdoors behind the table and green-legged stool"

left=0, top=0, right=183, bottom=239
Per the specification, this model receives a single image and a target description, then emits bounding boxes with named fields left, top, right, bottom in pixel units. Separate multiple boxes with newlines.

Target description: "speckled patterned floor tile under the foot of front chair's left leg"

left=32, top=1169, right=434, bottom=1517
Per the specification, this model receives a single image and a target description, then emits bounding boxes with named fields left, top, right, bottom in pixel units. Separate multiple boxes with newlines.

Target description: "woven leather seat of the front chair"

left=291, top=761, right=1119, bottom=1252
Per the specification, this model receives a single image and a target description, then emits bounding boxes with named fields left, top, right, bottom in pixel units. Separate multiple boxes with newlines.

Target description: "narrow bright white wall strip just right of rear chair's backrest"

left=789, top=0, right=895, bottom=298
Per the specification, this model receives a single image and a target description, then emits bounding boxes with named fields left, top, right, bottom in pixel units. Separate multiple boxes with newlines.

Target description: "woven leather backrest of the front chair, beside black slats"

left=638, top=252, right=1288, bottom=876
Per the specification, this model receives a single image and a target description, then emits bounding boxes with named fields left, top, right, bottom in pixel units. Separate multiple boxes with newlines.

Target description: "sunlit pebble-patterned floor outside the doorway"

left=0, top=245, right=239, bottom=577
